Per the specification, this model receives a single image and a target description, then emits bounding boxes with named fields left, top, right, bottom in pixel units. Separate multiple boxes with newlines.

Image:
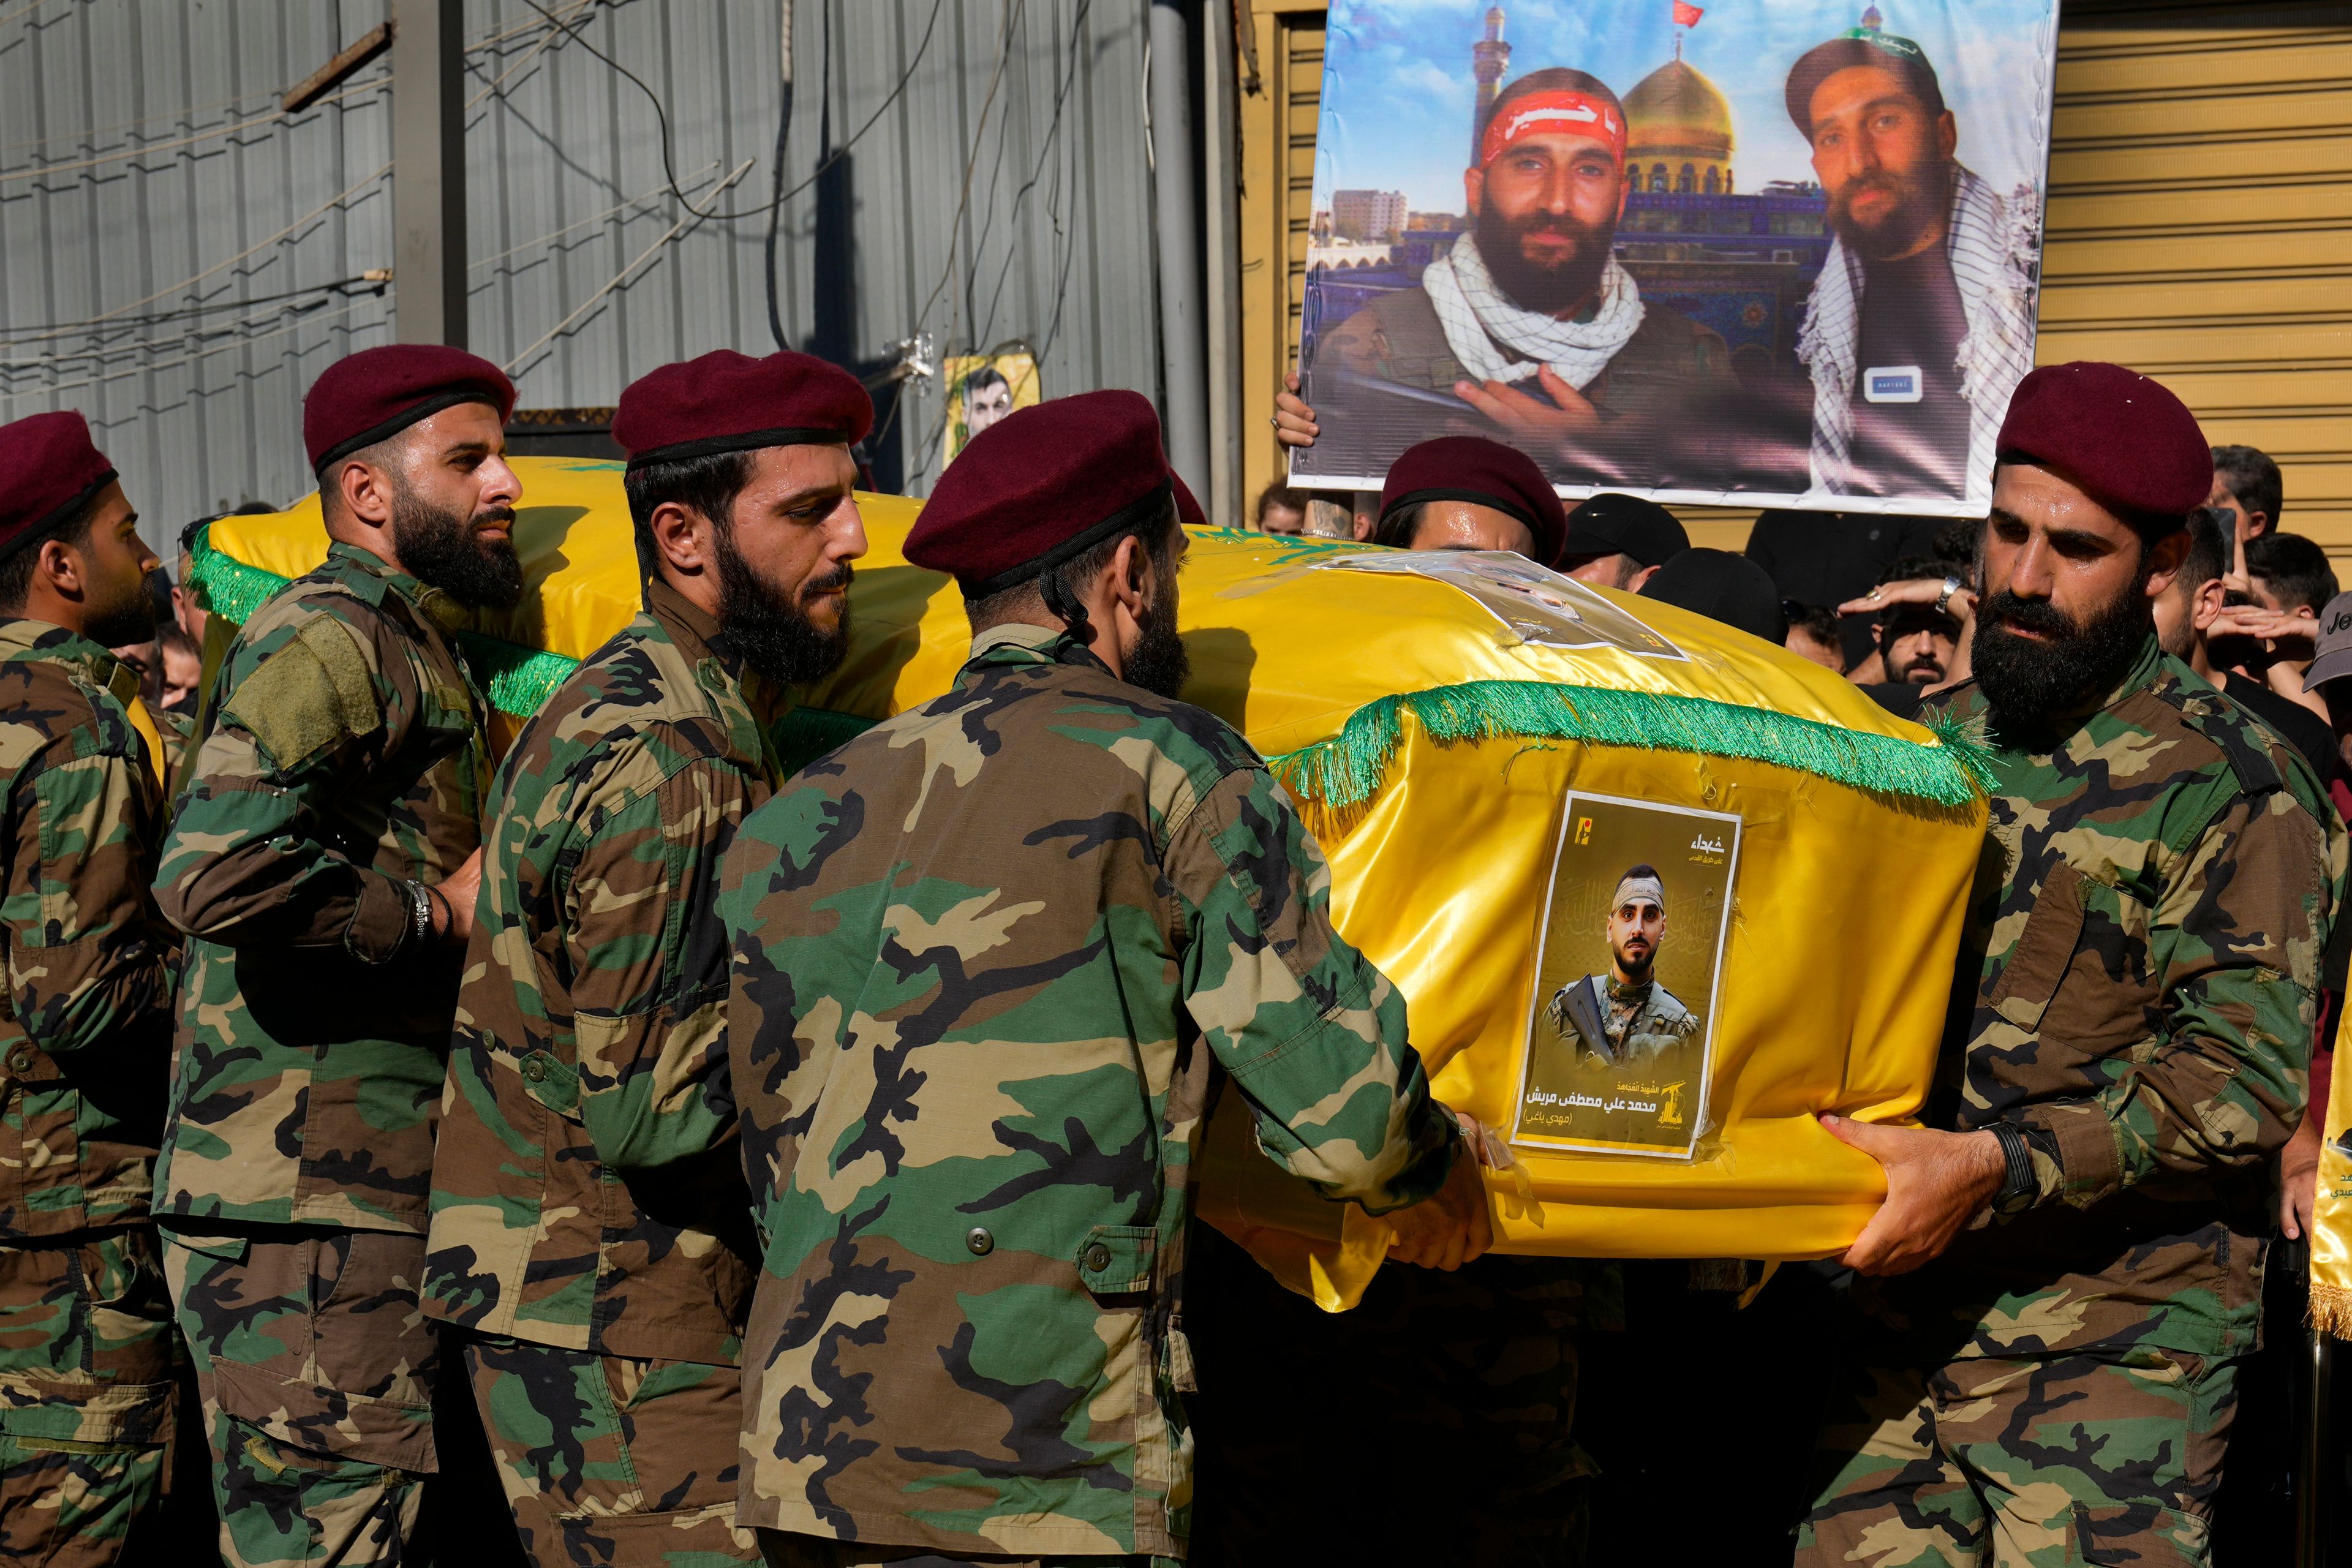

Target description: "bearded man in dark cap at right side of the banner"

left=1787, top=26, right=2041, bottom=508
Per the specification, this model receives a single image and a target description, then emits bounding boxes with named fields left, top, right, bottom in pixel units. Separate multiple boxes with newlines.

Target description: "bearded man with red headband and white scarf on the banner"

left=1277, top=68, right=1738, bottom=482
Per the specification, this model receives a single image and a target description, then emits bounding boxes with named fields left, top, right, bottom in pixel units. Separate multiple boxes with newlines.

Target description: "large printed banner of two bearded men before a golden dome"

left=1291, top=0, right=2058, bottom=517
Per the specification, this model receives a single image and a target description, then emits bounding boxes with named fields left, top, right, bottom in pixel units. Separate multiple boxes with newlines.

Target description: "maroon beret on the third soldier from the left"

left=611, top=348, right=875, bottom=468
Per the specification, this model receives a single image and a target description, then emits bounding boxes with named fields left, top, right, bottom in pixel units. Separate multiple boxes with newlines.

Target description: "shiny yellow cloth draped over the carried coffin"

left=212, top=458, right=1985, bottom=1310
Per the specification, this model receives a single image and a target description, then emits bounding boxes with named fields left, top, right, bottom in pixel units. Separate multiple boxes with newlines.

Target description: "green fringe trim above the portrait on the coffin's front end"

left=1268, top=679, right=1985, bottom=811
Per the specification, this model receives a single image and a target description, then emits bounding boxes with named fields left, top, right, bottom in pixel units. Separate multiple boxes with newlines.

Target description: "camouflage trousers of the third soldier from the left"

left=449, top=1330, right=760, bottom=1568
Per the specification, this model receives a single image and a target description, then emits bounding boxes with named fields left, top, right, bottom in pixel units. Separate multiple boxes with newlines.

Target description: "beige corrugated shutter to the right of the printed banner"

left=2039, top=0, right=2352, bottom=564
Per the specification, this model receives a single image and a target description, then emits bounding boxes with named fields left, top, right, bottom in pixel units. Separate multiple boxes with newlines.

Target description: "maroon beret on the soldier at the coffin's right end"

left=1997, top=360, right=2213, bottom=519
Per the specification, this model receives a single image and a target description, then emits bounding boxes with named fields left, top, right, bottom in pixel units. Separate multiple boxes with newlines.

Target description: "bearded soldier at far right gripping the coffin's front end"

left=1797, top=364, right=2345, bottom=1568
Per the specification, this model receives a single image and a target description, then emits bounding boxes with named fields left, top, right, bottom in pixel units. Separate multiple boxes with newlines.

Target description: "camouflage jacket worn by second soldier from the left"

left=155, top=543, right=489, bottom=1232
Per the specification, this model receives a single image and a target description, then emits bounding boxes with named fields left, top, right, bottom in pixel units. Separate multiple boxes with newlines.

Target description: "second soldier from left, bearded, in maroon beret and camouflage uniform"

left=155, top=345, right=522, bottom=1566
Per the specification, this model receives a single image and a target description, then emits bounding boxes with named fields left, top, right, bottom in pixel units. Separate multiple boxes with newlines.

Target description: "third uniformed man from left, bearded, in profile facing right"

left=426, top=350, right=873, bottom=1568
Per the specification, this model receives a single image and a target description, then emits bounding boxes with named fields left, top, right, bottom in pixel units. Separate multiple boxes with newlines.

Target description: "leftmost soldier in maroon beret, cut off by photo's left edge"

left=0, top=414, right=174, bottom=1568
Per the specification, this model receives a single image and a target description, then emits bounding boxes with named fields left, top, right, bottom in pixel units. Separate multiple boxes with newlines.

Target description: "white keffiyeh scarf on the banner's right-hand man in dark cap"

left=1797, top=169, right=2041, bottom=505
